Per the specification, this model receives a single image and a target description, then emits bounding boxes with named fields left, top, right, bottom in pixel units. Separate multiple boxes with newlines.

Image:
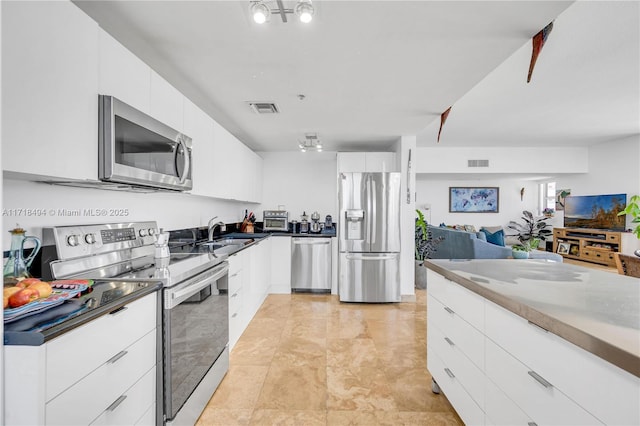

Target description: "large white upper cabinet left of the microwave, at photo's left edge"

left=2, top=2, right=99, bottom=179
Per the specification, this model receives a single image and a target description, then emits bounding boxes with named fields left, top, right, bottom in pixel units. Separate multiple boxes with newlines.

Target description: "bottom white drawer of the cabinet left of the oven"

left=91, top=368, right=156, bottom=426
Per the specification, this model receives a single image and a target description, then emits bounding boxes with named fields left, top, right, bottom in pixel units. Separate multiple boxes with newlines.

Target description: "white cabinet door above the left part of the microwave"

left=98, top=29, right=151, bottom=114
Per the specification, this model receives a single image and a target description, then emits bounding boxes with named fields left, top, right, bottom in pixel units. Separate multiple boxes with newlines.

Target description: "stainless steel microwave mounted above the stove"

left=98, top=95, right=193, bottom=191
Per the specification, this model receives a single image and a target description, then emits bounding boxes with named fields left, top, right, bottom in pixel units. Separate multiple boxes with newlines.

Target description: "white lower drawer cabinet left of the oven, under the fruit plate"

left=4, top=293, right=158, bottom=425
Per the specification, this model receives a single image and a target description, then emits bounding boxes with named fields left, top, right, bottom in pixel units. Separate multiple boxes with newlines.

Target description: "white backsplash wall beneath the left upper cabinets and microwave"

left=2, top=179, right=255, bottom=250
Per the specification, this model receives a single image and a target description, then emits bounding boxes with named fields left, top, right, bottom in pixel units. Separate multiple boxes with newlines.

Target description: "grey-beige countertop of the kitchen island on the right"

left=424, top=259, right=640, bottom=377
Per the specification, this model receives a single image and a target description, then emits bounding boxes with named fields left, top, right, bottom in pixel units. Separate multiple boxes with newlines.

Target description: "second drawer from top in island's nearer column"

left=486, top=340, right=602, bottom=426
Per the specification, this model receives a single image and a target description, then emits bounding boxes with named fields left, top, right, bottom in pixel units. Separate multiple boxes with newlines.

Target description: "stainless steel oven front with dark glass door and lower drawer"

left=163, top=262, right=229, bottom=424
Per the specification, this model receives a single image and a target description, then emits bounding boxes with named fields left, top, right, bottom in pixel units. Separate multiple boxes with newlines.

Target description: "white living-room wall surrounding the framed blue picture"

left=416, top=174, right=538, bottom=229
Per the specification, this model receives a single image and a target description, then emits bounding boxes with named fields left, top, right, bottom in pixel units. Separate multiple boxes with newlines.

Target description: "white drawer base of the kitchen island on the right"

left=427, top=270, right=640, bottom=425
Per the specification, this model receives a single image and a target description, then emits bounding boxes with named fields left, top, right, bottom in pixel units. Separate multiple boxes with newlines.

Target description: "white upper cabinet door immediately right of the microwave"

left=184, top=99, right=216, bottom=197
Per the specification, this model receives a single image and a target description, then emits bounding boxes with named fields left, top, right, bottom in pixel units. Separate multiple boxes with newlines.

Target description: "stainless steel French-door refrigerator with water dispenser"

left=338, top=173, right=400, bottom=303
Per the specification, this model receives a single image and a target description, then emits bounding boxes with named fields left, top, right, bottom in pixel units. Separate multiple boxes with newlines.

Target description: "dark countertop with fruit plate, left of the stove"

left=4, top=280, right=162, bottom=346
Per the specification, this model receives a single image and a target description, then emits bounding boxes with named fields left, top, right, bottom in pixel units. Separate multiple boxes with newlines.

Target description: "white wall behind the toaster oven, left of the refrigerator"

left=256, top=151, right=338, bottom=222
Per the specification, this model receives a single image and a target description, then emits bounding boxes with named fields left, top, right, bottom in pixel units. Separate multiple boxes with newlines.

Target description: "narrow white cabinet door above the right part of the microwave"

left=150, top=70, right=182, bottom=131
